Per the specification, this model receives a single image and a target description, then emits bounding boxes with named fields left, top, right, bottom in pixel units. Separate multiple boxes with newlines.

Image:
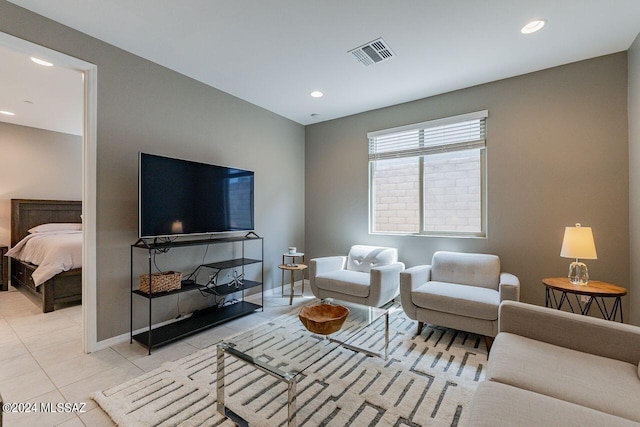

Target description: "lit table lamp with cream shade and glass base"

left=560, top=224, right=598, bottom=285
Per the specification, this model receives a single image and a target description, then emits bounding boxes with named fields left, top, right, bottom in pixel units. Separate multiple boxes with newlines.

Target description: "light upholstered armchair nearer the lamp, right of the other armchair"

left=400, top=252, right=520, bottom=344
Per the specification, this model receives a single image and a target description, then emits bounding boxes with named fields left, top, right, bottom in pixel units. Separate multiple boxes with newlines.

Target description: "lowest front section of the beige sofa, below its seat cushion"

left=468, top=382, right=637, bottom=427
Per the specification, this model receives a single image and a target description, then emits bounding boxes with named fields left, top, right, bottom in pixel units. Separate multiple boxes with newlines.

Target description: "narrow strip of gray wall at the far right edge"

left=628, top=35, right=640, bottom=326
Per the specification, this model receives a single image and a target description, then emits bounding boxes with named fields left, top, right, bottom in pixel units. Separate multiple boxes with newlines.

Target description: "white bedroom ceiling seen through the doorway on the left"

left=0, top=45, right=83, bottom=135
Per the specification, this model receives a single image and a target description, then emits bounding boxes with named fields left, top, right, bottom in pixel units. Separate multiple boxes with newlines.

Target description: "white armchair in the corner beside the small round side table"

left=309, top=245, right=404, bottom=307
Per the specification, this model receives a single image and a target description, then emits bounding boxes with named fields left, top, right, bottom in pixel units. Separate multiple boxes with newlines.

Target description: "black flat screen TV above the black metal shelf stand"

left=138, top=153, right=254, bottom=238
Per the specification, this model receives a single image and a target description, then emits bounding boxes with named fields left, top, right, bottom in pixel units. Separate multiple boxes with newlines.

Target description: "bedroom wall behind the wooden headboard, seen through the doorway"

left=0, top=122, right=82, bottom=245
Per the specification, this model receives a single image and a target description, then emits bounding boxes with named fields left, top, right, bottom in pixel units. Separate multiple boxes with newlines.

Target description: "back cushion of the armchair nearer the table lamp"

left=431, top=251, right=500, bottom=291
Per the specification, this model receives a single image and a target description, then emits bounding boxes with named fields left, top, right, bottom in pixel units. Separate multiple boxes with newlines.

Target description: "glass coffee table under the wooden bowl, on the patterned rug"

left=216, top=300, right=389, bottom=426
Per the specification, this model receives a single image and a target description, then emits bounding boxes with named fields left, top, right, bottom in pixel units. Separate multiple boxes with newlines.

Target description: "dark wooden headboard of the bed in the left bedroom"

left=11, top=199, right=82, bottom=247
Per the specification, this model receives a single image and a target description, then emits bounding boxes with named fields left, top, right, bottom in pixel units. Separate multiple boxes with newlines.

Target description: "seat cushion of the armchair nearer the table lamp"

left=411, top=281, right=500, bottom=320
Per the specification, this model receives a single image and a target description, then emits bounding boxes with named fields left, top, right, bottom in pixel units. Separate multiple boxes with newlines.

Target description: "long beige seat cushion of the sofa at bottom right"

left=486, top=332, right=640, bottom=422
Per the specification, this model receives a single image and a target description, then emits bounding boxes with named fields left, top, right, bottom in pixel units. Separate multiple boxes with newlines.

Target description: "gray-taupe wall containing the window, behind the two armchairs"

left=305, top=53, right=629, bottom=320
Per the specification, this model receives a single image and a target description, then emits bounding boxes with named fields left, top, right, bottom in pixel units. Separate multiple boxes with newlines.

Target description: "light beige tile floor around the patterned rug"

left=0, top=285, right=313, bottom=427
